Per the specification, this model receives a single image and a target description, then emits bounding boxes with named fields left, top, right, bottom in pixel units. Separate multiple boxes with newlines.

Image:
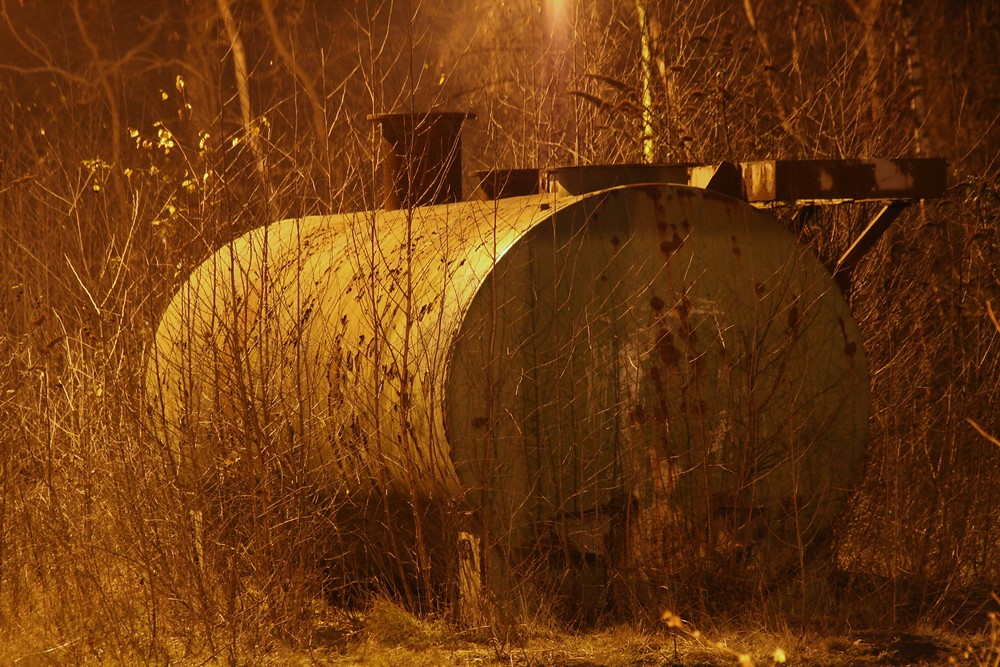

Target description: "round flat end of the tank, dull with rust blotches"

left=444, top=185, right=870, bottom=569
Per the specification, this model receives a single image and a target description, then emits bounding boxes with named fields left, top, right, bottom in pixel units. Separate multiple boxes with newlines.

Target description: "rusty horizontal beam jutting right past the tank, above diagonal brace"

left=741, top=158, right=947, bottom=203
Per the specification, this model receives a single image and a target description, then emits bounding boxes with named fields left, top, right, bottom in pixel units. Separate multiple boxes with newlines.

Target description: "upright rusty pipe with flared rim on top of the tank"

left=368, top=111, right=476, bottom=211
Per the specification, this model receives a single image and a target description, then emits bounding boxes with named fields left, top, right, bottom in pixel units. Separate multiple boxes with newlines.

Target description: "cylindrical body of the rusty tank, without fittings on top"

left=147, top=184, right=870, bottom=570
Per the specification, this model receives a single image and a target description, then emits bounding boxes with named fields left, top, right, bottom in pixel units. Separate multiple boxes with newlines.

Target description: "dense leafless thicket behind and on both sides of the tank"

left=0, top=0, right=1000, bottom=658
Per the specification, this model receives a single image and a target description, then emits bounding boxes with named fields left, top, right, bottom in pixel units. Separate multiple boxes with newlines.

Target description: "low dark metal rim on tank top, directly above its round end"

left=542, top=164, right=689, bottom=197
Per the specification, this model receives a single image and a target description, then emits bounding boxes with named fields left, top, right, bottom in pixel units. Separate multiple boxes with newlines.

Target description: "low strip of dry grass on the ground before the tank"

left=64, top=600, right=984, bottom=667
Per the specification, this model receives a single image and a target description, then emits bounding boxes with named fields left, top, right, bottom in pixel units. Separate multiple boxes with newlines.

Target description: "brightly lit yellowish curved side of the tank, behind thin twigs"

left=147, top=198, right=551, bottom=498
